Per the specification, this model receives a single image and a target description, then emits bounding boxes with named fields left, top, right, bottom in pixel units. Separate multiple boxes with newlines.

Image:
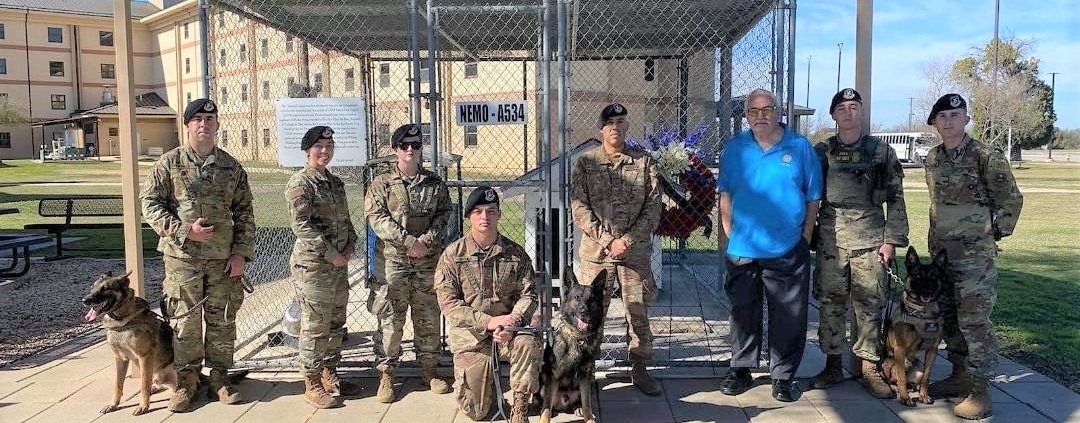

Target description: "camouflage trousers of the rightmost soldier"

left=939, top=250, right=998, bottom=378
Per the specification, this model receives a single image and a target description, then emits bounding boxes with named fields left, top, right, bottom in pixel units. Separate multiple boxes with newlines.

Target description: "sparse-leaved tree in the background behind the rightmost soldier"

left=949, top=38, right=1056, bottom=151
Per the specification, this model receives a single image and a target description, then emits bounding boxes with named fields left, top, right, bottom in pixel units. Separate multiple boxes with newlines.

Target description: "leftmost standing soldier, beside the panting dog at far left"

left=140, top=98, right=255, bottom=411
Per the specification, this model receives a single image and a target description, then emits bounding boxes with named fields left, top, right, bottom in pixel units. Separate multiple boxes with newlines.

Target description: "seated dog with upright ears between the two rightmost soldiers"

left=882, top=247, right=948, bottom=406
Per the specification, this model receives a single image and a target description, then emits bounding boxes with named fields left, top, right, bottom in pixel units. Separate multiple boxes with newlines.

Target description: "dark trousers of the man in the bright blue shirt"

left=724, top=238, right=810, bottom=380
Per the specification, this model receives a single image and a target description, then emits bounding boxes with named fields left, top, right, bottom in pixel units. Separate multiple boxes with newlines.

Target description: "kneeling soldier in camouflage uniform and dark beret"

left=435, top=187, right=540, bottom=423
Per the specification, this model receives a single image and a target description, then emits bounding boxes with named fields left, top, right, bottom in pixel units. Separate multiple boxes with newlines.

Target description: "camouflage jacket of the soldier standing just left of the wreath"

left=570, top=146, right=660, bottom=262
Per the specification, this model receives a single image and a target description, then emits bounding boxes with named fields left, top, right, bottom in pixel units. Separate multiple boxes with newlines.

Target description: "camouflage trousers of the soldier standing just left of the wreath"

left=579, top=259, right=657, bottom=363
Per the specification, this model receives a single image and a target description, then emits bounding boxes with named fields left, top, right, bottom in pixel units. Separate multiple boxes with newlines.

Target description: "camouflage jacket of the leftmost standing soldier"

left=140, top=145, right=255, bottom=260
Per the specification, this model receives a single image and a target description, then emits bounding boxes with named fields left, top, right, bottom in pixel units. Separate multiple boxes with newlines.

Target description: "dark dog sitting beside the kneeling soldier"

left=540, top=270, right=608, bottom=423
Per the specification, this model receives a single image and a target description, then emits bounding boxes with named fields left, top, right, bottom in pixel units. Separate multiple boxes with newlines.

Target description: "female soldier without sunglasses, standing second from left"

left=285, top=126, right=360, bottom=408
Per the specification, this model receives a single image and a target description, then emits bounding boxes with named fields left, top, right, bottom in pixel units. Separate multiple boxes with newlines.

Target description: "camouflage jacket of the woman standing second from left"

left=285, top=166, right=359, bottom=263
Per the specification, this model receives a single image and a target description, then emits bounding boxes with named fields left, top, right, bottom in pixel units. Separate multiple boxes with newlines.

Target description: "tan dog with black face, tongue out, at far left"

left=82, top=273, right=176, bottom=415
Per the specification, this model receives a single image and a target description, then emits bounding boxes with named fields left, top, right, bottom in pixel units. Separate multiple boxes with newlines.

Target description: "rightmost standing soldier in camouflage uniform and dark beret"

left=926, top=94, right=1024, bottom=419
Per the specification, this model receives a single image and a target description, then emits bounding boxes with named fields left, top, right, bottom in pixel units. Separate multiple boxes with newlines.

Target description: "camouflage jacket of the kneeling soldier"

left=435, top=235, right=537, bottom=354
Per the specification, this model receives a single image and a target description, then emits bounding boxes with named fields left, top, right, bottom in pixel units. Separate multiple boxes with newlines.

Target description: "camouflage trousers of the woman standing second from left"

left=293, top=263, right=349, bottom=376
